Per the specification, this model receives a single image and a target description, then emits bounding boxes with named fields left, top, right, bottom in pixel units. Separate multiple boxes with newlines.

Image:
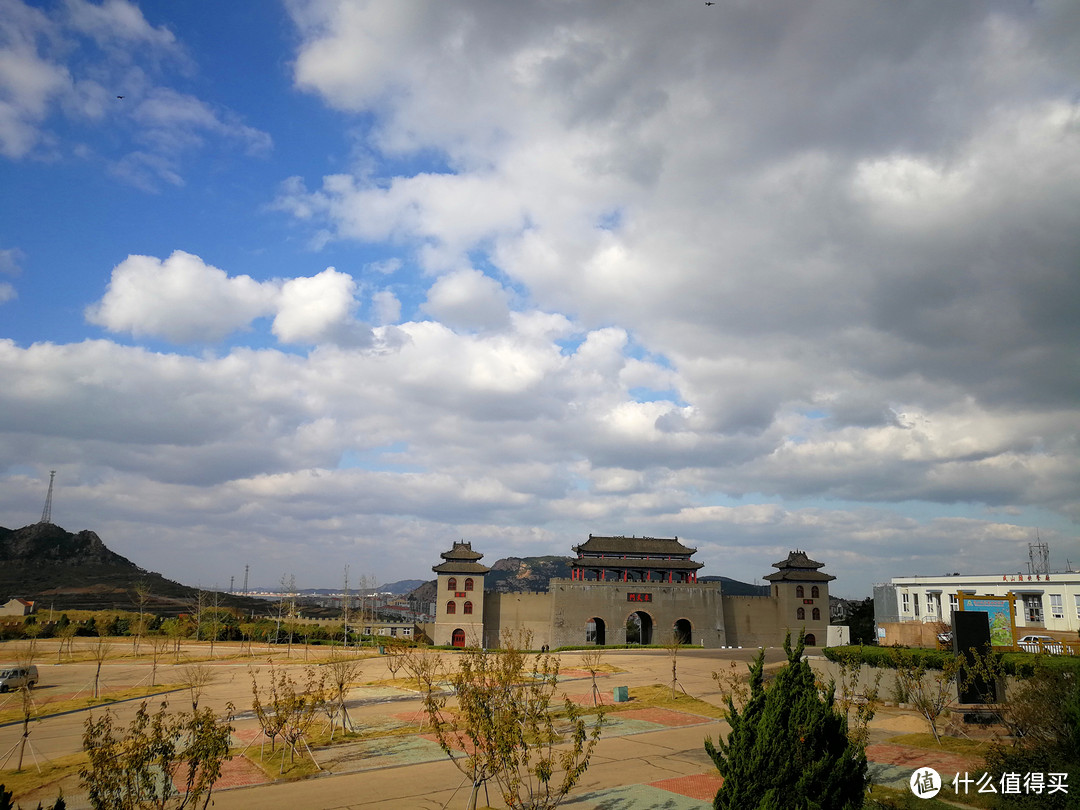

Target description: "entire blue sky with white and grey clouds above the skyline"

left=0, top=0, right=1080, bottom=596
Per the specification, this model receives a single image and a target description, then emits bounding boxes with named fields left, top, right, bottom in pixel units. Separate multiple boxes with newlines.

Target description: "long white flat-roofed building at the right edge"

left=874, top=571, right=1080, bottom=642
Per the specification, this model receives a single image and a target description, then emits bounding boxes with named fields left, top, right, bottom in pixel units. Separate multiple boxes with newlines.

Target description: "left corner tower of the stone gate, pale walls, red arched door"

left=431, top=541, right=491, bottom=647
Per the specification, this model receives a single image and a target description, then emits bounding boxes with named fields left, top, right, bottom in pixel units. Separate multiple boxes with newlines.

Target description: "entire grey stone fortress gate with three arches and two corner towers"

left=429, top=535, right=833, bottom=648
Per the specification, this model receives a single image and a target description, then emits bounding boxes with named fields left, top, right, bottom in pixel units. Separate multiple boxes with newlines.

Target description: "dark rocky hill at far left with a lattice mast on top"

left=0, top=523, right=269, bottom=615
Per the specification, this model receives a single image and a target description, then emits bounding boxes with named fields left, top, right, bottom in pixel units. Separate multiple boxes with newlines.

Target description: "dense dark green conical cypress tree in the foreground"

left=705, top=634, right=866, bottom=810
